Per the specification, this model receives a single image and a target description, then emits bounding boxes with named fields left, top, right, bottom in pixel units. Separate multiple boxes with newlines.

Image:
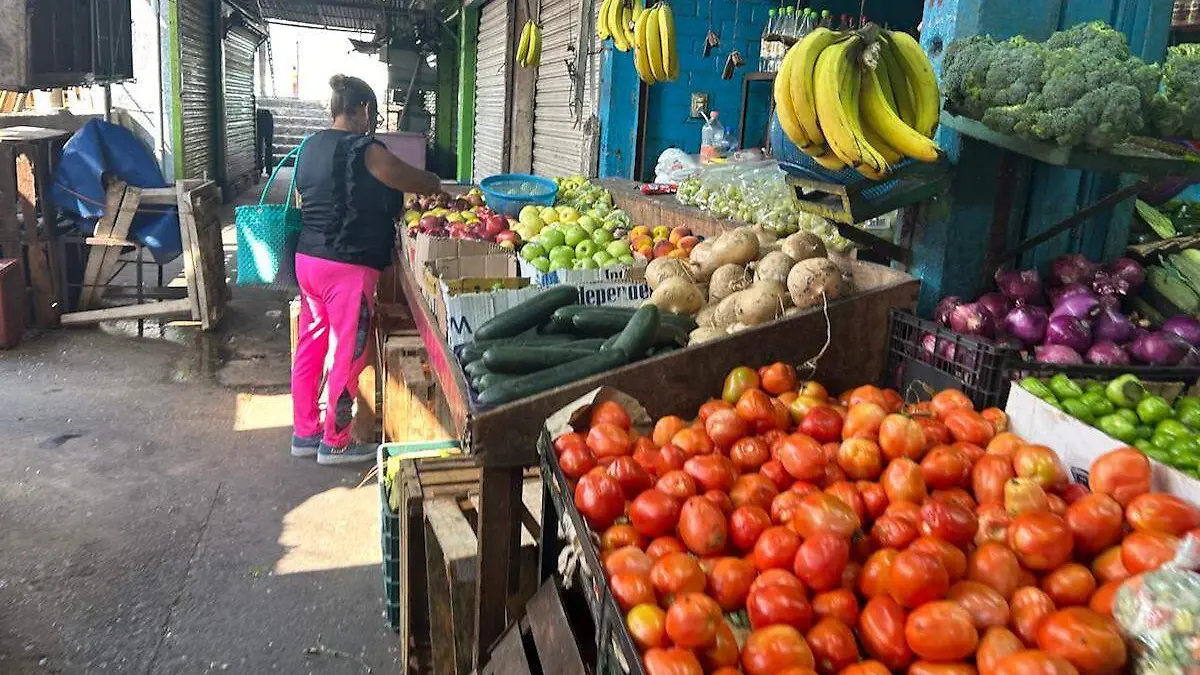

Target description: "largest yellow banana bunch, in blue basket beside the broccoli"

left=774, top=24, right=941, bottom=180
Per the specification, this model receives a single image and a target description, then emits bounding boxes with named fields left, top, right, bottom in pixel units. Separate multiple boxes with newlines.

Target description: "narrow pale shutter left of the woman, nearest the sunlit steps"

left=223, top=26, right=258, bottom=192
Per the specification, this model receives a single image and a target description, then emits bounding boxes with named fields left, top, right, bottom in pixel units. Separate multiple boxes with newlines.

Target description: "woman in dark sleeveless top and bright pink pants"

left=292, top=74, right=440, bottom=464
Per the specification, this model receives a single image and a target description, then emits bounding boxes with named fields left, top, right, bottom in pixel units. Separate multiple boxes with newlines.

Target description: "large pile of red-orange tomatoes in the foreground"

left=554, top=363, right=1200, bottom=675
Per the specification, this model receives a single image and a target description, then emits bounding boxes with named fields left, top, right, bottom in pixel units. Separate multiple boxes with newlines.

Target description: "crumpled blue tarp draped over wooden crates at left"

left=50, top=120, right=184, bottom=264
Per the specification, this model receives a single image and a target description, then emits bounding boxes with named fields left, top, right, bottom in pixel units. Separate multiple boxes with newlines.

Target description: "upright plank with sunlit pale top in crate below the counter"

left=425, top=497, right=475, bottom=674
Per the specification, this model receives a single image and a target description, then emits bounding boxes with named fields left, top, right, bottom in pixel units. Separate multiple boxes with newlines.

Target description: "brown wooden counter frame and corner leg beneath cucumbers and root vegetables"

left=400, top=248, right=920, bottom=664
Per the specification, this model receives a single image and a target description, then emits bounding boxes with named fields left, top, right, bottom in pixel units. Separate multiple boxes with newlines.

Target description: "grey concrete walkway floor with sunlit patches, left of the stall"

left=0, top=174, right=401, bottom=675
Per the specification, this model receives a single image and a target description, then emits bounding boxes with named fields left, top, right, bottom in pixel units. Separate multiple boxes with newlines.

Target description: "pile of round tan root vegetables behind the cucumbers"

left=646, top=226, right=854, bottom=345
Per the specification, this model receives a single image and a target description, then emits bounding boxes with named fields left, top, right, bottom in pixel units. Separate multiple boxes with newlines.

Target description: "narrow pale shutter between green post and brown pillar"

left=472, top=0, right=509, bottom=183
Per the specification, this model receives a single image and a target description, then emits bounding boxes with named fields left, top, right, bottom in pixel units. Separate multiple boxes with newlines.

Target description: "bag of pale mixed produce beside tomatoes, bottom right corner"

left=1112, top=534, right=1200, bottom=675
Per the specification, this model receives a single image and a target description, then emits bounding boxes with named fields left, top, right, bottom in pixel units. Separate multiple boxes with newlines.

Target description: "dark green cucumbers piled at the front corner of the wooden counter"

left=458, top=285, right=696, bottom=406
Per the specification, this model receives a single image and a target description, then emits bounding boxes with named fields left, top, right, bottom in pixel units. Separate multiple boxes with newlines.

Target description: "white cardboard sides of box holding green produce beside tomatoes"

left=1004, top=386, right=1200, bottom=503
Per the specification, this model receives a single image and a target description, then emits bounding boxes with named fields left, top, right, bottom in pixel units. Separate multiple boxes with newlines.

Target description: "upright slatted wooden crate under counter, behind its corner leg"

left=397, top=458, right=541, bottom=675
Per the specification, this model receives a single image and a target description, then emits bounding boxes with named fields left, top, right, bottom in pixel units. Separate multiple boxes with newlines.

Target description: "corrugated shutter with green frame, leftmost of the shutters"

left=179, top=0, right=217, bottom=178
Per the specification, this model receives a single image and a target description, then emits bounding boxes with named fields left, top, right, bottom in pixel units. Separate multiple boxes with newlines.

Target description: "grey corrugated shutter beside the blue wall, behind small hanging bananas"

left=533, top=0, right=600, bottom=178
